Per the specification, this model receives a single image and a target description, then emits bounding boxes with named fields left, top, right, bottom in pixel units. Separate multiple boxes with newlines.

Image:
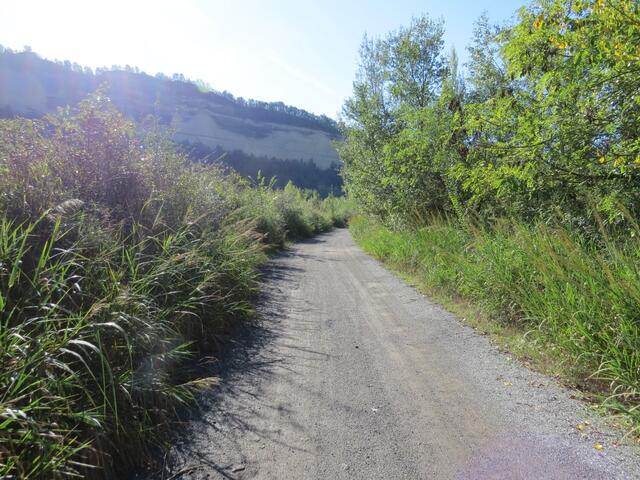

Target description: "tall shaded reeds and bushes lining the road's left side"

left=0, top=96, right=348, bottom=479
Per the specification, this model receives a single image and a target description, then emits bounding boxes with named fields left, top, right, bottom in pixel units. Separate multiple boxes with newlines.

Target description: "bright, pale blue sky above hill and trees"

left=0, top=0, right=525, bottom=118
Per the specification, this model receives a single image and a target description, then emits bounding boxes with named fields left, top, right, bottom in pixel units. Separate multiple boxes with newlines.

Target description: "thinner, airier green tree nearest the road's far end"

left=340, top=15, right=447, bottom=222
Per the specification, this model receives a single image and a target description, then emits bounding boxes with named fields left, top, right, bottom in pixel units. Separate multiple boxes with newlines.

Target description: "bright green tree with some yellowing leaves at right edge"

left=456, top=0, right=640, bottom=224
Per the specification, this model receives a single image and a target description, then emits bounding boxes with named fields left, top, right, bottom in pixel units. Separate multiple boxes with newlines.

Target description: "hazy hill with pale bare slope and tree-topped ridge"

left=0, top=47, right=339, bottom=178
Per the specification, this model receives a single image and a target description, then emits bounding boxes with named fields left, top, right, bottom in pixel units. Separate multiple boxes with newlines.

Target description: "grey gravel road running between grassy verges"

left=167, top=230, right=640, bottom=479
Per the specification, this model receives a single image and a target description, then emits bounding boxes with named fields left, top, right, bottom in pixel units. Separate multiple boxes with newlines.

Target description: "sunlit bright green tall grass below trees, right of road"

left=351, top=218, right=640, bottom=424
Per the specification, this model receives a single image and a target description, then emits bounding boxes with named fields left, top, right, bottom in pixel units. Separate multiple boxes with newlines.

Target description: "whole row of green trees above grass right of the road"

left=341, top=0, right=640, bottom=228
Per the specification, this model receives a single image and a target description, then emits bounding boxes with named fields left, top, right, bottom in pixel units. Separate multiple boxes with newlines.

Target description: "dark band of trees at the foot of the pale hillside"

left=181, top=142, right=342, bottom=197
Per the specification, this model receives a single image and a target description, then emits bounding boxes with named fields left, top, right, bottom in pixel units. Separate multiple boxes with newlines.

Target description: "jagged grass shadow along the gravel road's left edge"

left=143, top=248, right=326, bottom=480
